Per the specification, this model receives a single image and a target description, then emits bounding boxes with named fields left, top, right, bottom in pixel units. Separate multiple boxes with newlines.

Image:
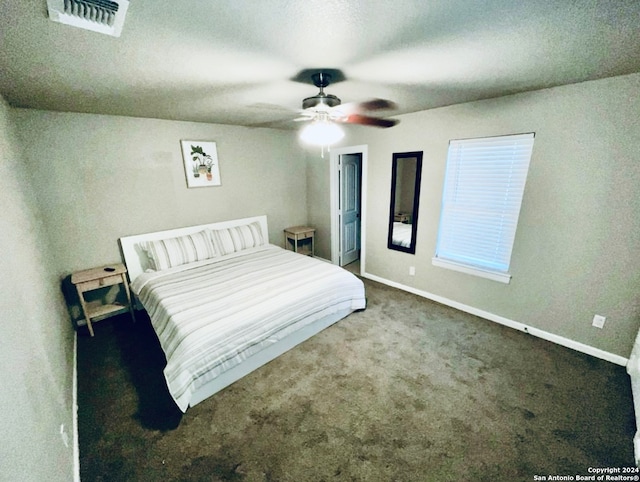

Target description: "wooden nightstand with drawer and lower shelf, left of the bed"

left=71, top=263, right=135, bottom=336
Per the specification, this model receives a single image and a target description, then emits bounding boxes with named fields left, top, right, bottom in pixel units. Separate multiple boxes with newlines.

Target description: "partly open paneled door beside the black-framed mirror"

left=338, top=153, right=362, bottom=266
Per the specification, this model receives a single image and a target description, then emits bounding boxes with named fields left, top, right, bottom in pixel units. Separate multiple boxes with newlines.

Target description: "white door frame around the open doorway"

left=329, top=144, right=368, bottom=273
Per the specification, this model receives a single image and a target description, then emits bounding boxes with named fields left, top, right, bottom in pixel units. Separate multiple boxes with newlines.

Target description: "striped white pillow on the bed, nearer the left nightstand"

left=142, top=231, right=217, bottom=270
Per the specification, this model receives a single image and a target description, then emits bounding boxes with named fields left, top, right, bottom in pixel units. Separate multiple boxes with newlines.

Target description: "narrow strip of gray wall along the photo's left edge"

left=0, top=97, right=74, bottom=482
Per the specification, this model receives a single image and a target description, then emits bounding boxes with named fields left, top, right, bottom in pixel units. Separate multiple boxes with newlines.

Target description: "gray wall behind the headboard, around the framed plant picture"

left=12, top=109, right=307, bottom=275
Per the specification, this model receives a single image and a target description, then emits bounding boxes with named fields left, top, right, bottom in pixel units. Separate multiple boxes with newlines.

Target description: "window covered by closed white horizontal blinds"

left=433, top=133, right=534, bottom=283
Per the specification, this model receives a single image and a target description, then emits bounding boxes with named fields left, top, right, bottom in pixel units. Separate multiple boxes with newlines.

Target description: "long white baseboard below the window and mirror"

left=362, top=272, right=629, bottom=366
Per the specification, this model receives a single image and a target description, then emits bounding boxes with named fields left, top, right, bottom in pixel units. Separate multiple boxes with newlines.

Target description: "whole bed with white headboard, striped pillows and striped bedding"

left=120, top=216, right=366, bottom=412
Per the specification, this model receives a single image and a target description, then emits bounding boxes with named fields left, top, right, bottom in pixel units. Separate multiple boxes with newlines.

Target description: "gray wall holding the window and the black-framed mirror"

left=310, top=74, right=640, bottom=357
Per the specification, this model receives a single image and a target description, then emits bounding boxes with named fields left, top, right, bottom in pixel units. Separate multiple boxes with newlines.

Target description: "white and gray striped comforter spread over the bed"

left=132, top=245, right=365, bottom=412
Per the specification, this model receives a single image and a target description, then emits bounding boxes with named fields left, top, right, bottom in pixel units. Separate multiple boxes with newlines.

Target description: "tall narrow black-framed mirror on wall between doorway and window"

left=387, top=151, right=422, bottom=254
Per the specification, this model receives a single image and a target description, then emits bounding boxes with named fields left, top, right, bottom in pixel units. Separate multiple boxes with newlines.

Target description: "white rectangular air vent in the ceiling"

left=47, top=0, right=129, bottom=37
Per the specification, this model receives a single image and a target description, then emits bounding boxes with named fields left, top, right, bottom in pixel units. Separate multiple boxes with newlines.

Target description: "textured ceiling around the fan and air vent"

left=0, top=0, right=640, bottom=128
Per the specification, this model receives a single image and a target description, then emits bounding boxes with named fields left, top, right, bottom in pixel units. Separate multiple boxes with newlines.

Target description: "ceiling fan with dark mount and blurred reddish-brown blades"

left=296, top=71, right=399, bottom=128
